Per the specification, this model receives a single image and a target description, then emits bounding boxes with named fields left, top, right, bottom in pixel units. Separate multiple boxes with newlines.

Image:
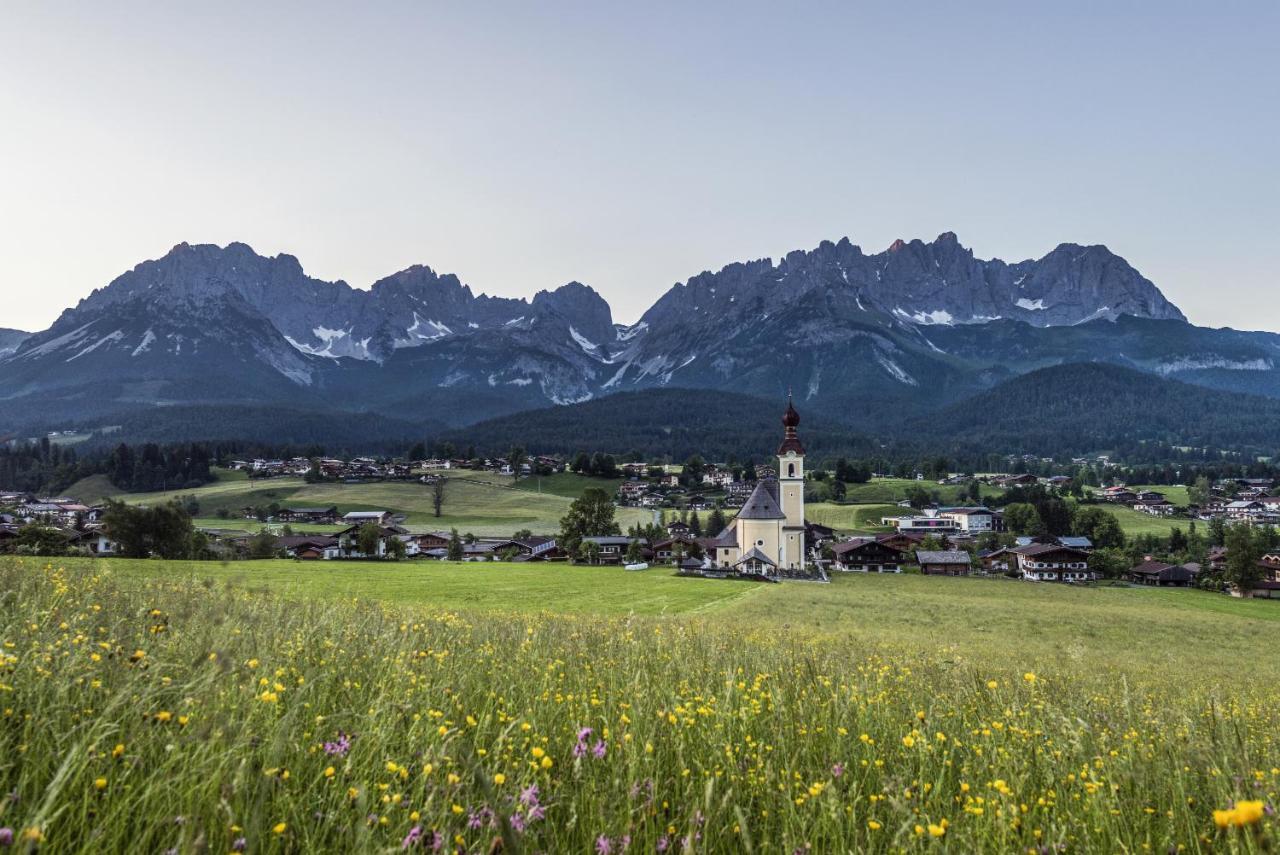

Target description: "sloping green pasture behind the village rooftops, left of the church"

left=102, top=472, right=653, bottom=536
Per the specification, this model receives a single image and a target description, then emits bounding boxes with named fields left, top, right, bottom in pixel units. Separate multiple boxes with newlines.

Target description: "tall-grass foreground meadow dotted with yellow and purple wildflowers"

left=0, top=561, right=1280, bottom=855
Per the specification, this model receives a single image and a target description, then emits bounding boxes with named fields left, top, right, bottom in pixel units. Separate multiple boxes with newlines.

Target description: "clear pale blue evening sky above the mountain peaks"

left=0, top=0, right=1280, bottom=330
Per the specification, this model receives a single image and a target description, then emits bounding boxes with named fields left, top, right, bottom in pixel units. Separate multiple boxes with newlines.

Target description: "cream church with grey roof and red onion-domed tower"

left=707, top=394, right=805, bottom=576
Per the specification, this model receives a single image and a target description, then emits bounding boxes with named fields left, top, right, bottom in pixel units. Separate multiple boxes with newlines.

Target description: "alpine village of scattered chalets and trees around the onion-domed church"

left=0, top=402, right=1280, bottom=598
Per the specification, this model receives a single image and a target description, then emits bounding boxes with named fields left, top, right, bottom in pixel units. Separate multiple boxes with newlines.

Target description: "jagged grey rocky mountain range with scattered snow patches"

left=0, top=232, right=1280, bottom=447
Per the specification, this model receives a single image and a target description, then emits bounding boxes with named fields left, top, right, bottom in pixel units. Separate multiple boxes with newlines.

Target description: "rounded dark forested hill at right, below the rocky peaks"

left=899, top=362, right=1280, bottom=456
